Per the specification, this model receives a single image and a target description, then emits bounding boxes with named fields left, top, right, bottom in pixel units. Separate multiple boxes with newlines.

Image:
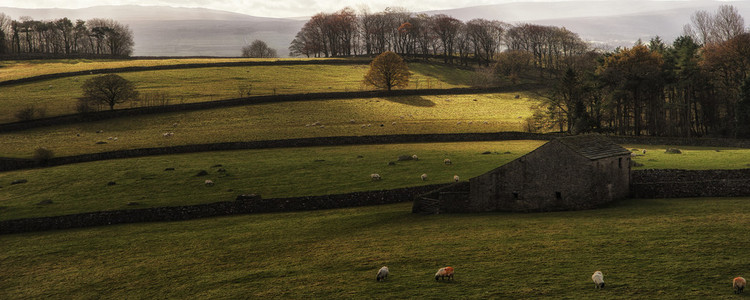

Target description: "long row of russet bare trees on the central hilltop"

left=289, top=7, right=587, bottom=66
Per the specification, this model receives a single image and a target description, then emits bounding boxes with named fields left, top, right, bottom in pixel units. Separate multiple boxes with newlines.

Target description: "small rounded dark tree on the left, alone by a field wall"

left=81, top=74, right=138, bottom=110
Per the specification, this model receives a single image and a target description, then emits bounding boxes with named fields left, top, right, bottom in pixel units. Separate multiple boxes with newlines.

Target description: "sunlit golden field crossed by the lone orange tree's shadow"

left=0, top=94, right=534, bottom=157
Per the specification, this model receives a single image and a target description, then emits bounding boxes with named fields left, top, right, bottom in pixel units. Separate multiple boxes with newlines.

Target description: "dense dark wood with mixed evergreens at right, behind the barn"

left=530, top=5, right=750, bottom=138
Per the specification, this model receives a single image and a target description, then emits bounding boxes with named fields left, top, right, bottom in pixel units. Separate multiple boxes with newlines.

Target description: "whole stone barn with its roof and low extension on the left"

left=412, top=134, right=630, bottom=213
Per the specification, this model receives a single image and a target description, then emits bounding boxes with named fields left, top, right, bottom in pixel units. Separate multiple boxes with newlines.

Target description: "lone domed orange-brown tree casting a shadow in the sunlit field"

left=364, top=51, right=411, bottom=91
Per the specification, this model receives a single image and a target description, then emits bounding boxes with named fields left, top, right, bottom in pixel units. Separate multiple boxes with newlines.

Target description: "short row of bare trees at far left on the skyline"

left=0, top=13, right=134, bottom=56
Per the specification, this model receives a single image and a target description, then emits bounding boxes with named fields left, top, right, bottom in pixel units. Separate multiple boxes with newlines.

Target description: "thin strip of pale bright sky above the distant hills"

left=0, top=0, right=700, bottom=18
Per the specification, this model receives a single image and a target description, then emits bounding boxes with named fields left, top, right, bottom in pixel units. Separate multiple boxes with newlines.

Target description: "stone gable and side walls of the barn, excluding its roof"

left=470, top=142, right=630, bottom=211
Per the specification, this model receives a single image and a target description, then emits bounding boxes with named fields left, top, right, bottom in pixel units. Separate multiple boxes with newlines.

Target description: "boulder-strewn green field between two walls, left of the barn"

left=0, top=141, right=542, bottom=220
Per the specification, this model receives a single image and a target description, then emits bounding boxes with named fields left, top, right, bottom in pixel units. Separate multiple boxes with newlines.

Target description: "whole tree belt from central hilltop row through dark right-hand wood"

left=289, top=5, right=750, bottom=137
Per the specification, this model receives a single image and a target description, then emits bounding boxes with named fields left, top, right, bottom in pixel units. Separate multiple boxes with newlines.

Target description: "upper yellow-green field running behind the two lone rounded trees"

left=0, top=64, right=470, bottom=123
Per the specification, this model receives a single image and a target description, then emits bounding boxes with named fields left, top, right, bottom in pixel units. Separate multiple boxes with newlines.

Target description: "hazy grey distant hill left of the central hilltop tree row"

left=0, top=5, right=305, bottom=56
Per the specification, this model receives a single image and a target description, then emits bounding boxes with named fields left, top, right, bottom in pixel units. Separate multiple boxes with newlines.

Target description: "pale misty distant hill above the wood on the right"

left=428, top=0, right=750, bottom=47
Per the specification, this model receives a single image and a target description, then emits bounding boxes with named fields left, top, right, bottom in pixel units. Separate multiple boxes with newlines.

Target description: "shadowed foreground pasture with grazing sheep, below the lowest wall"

left=0, top=198, right=750, bottom=299
